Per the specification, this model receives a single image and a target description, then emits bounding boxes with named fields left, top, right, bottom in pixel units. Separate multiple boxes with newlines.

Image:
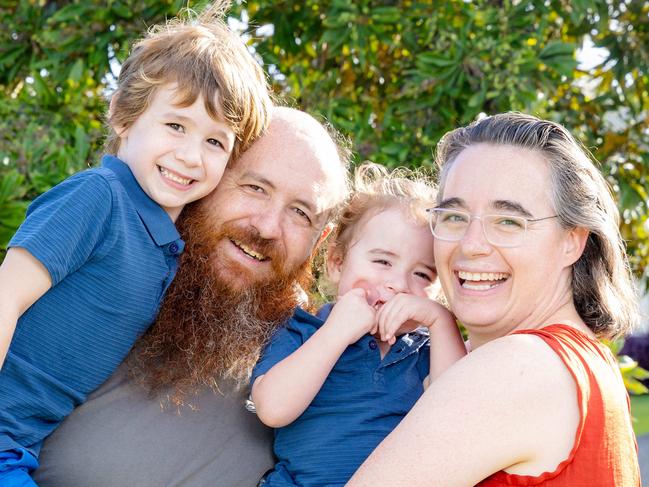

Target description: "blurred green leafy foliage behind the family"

left=0, top=0, right=649, bottom=288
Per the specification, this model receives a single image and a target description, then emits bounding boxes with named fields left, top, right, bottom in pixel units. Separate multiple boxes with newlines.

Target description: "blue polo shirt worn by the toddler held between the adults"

left=251, top=305, right=430, bottom=487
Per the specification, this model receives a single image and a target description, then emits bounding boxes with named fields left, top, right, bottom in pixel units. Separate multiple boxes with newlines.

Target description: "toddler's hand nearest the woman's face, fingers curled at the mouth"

left=377, top=293, right=452, bottom=345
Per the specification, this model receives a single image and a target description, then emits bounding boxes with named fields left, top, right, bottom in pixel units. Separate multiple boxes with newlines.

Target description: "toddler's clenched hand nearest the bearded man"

left=323, top=288, right=378, bottom=345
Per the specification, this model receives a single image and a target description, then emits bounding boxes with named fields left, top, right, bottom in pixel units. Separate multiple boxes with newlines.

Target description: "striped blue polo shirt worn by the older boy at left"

left=0, top=156, right=184, bottom=455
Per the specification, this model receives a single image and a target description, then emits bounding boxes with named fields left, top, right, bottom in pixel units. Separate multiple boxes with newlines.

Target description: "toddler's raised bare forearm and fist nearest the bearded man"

left=252, top=289, right=376, bottom=428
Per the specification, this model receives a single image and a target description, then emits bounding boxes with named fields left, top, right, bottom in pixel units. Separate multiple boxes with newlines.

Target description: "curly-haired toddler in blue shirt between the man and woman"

left=251, top=165, right=465, bottom=487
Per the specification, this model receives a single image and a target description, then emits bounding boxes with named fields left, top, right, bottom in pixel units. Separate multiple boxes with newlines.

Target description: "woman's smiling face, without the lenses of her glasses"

left=435, top=143, right=574, bottom=342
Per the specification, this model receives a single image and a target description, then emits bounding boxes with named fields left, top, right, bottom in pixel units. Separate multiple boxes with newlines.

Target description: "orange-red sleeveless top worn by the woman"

left=477, top=325, right=640, bottom=487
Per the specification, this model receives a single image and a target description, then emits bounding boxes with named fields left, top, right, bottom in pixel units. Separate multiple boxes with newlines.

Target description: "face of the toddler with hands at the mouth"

left=329, top=208, right=437, bottom=308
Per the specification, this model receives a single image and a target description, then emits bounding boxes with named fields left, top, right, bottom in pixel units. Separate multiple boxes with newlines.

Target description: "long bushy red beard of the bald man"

left=129, top=203, right=311, bottom=406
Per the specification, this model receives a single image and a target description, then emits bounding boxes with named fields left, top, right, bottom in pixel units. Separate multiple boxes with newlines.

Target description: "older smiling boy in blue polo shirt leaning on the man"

left=0, top=6, right=270, bottom=487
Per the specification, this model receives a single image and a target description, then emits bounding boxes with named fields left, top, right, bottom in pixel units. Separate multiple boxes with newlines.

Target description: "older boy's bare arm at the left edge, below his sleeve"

left=0, top=247, right=52, bottom=367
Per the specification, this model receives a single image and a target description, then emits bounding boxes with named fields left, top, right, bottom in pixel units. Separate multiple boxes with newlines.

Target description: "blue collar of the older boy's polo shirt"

left=101, top=155, right=180, bottom=247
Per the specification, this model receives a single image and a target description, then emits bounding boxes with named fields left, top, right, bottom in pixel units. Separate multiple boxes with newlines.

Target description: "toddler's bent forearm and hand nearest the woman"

left=378, top=293, right=466, bottom=385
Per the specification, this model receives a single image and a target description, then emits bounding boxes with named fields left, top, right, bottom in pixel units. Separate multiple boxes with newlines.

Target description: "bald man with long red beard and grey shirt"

left=34, top=108, right=347, bottom=487
